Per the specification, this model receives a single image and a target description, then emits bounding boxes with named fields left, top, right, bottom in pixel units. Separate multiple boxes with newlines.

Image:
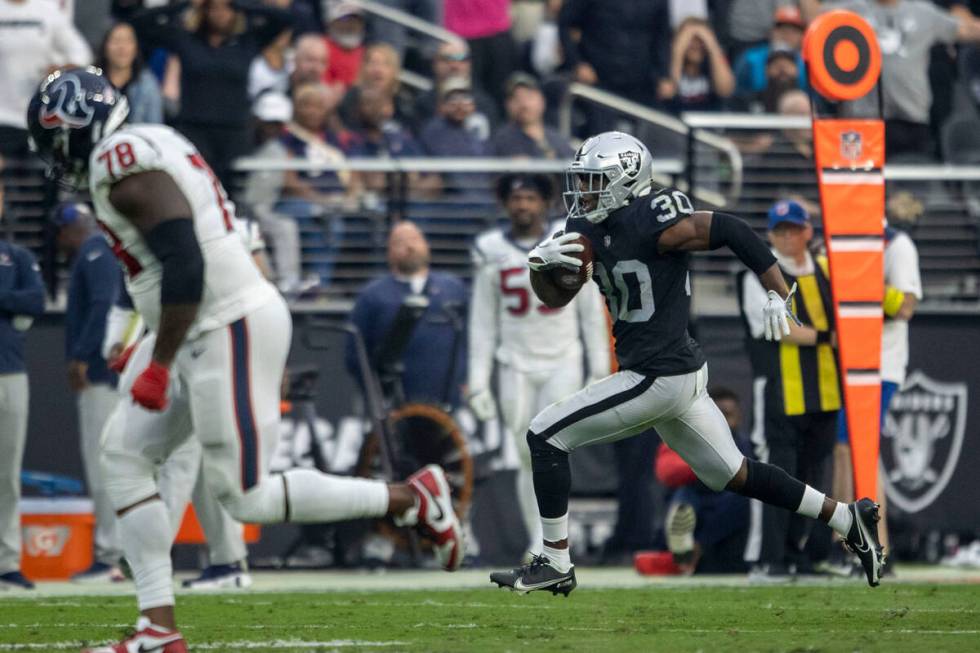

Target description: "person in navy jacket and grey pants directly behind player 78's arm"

left=53, top=204, right=121, bottom=580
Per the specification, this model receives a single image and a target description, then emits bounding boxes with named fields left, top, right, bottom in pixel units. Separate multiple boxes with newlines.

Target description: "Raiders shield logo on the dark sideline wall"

left=881, top=370, right=967, bottom=513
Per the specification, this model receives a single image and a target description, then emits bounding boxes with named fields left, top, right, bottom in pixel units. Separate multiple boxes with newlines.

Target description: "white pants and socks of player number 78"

left=102, top=296, right=388, bottom=610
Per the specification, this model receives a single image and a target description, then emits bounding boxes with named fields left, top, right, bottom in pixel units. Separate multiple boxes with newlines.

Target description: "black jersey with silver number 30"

left=565, top=188, right=705, bottom=376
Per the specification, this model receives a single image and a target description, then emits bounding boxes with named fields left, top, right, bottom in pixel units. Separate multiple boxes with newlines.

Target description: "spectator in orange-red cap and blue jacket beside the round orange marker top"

left=735, top=6, right=807, bottom=98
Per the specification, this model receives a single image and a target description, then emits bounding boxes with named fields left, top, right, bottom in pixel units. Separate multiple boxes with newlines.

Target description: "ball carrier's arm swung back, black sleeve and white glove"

left=657, top=211, right=804, bottom=345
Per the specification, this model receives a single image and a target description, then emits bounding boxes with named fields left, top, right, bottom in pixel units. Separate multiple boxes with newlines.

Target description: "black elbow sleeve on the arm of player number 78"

left=145, top=218, right=204, bottom=304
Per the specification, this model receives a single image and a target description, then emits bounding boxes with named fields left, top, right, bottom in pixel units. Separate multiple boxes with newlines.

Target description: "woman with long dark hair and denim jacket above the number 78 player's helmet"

left=95, top=23, right=163, bottom=123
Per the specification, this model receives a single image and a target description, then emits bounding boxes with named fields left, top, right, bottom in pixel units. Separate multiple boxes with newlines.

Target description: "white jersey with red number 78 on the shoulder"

left=89, top=125, right=276, bottom=338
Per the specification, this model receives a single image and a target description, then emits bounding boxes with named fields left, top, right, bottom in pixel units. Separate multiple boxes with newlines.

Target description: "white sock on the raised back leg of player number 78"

left=282, top=469, right=388, bottom=523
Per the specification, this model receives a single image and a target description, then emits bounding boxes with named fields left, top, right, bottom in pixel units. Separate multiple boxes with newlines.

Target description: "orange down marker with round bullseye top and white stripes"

left=803, top=10, right=885, bottom=499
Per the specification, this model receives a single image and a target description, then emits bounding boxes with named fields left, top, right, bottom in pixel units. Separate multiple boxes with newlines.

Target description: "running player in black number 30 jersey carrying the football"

left=490, top=132, right=884, bottom=596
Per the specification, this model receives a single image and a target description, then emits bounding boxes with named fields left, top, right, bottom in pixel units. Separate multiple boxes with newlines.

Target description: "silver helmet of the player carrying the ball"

left=562, top=132, right=653, bottom=222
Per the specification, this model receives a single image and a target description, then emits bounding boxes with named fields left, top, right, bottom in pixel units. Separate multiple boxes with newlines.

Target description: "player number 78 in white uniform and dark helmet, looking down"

left=27, top=68, right=463, bottom=653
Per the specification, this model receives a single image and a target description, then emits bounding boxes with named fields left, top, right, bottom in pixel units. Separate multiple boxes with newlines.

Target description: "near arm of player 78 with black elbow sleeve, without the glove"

left=109, top=170, right=204, bottom=367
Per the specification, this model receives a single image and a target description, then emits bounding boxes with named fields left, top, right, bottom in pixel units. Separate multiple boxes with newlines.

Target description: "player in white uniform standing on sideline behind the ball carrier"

left=468, top=174, right=610, bottom=555
